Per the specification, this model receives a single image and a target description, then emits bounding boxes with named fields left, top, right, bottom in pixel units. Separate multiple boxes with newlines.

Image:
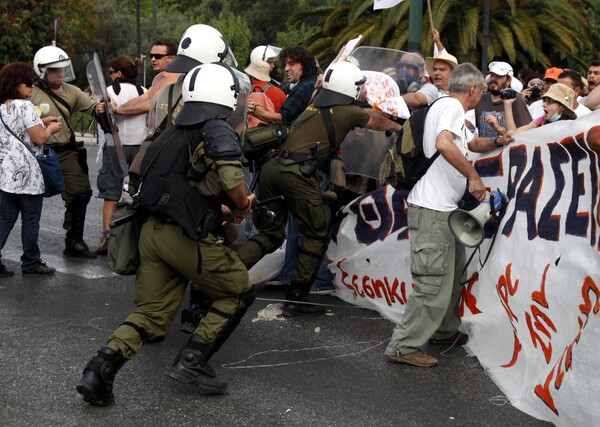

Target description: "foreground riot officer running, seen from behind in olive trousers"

left=77, top=64, right=254, bottom=406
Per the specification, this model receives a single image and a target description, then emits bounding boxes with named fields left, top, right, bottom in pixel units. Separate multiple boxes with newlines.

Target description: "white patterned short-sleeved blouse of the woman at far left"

left=0, top=99, right=45, bottom=194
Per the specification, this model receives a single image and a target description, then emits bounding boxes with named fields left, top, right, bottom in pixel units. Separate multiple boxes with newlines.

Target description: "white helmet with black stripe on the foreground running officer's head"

left=174, top=62, right=240, bottom=126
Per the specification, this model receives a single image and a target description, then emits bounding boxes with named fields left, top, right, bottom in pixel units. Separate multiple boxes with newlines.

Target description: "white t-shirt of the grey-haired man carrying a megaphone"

left=407, top=97, right=473, bottom=212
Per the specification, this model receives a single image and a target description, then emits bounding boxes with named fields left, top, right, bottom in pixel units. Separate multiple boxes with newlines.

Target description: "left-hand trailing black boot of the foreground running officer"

left=77, top=347, right=127, bottom=406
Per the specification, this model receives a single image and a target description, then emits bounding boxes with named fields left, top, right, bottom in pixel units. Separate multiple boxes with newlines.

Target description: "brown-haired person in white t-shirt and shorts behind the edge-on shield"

left=96, top=55, right=148, bottom=255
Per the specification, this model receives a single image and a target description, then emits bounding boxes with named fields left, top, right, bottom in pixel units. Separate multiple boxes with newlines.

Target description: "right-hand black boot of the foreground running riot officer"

left=167, top=336, right=227, bottom=394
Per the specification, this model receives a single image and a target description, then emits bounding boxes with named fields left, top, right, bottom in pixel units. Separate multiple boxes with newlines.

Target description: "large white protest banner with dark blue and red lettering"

left=328, top=111, right=600, bottom=426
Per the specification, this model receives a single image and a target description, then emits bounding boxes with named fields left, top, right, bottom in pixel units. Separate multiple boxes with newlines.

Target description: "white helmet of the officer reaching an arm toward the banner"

left=313, top=61, right=367, bottom=107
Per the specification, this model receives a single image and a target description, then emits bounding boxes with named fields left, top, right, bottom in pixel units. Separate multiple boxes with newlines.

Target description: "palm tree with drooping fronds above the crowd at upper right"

left=294, top=0, right=598, bottom=69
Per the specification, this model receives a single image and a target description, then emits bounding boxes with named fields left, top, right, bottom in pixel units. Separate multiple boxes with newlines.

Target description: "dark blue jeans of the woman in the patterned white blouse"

left=0, top=190, right=44, bottom=269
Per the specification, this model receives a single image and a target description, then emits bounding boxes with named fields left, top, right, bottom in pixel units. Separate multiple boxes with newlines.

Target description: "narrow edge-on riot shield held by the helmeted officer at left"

left=86, top=52, right=129, bottom=178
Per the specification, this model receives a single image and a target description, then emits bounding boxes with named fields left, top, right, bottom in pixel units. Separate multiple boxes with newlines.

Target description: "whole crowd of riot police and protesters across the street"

left=0, top=24, right=600, bottom=406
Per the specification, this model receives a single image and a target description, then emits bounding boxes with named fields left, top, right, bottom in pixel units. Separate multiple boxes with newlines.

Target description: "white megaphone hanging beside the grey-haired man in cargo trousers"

left=448, top=190, right=508, bottom=248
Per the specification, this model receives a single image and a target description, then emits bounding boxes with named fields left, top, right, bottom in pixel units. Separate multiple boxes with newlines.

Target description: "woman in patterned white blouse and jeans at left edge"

left=0, top=62, right=62, bottom=277
